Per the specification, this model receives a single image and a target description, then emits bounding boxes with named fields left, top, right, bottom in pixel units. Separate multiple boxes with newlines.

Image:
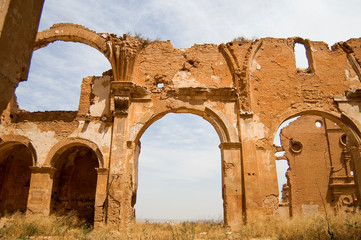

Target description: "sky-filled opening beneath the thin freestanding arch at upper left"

left=15, top=41, right=111, bottom=112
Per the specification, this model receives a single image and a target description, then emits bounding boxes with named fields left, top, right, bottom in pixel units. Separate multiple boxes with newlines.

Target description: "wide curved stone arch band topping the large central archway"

left=130, top=107, right=238, bottom=143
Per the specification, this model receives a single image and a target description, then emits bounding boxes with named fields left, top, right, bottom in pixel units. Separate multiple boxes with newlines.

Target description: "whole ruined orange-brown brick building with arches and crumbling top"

left=0, top=0, right=361, bottom=232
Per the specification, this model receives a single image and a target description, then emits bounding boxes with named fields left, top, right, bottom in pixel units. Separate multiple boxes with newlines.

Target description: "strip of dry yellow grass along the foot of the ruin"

left=0, top=213, right=361, bottom=240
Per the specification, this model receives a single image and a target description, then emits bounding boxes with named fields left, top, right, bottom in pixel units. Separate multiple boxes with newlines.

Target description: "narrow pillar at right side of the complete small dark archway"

left=94, top=168, right=109, bottom=228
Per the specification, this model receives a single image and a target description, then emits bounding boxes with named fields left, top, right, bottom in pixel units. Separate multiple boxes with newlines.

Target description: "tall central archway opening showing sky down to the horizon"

left=135, top=113, right=223, bottom=221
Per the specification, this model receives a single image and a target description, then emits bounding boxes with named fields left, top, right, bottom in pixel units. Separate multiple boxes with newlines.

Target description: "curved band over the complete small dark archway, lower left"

left=45, top=138, right=104, bottom=168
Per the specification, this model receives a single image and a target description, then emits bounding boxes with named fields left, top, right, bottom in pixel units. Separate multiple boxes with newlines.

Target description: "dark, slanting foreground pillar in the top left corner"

left=0, top=0, right=44, bottom=114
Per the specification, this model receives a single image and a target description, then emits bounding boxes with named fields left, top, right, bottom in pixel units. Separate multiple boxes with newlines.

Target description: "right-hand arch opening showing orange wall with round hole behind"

left=275, top=112, right=359, bottom=216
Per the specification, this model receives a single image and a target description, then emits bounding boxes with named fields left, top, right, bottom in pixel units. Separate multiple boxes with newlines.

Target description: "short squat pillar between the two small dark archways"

left=26, top=167, right=56, bottom=216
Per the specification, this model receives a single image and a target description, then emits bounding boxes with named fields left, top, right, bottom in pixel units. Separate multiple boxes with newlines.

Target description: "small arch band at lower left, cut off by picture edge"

left=0, top=135, right=37, bottom=166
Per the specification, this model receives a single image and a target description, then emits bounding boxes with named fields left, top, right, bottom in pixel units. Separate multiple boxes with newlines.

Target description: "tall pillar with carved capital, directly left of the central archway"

left=107, top=81, right=135, bottom=230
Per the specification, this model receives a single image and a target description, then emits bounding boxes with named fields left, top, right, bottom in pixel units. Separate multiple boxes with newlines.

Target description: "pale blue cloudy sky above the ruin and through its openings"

left=16, top=0, right=361, bottom=219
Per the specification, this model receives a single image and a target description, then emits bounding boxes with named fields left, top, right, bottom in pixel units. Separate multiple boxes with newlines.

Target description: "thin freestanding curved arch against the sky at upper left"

left=34, top=23, right=109, bottom=58
